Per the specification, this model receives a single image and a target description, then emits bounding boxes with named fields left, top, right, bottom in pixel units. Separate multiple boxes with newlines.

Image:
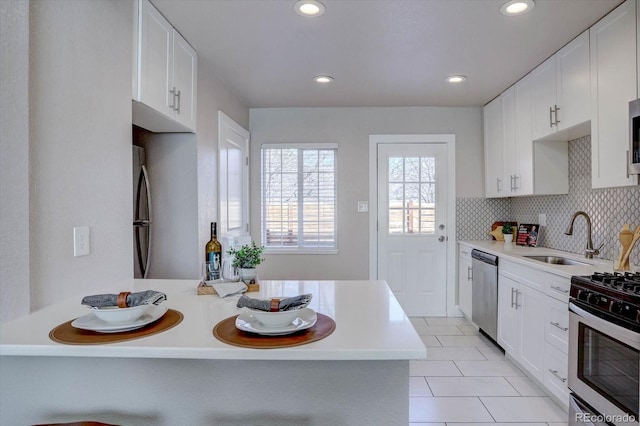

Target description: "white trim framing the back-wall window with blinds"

left=260, top=142, right=339, bottom=254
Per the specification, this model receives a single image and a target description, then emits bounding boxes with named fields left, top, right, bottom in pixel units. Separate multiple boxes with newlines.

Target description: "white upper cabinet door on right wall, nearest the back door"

left=484, top=97, right=508, bottom=198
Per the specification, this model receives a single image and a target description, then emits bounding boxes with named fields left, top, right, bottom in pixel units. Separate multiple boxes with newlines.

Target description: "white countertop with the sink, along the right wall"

left=458, top=240, right=613, bottom=278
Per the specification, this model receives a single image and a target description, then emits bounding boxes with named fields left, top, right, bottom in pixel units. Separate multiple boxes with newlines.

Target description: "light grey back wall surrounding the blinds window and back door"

left=250, top=107, right=484, bottom=279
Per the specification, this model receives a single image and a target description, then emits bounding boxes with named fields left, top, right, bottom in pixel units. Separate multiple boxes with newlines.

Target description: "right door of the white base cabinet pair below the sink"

left=516, top=285, right=547, bottom=381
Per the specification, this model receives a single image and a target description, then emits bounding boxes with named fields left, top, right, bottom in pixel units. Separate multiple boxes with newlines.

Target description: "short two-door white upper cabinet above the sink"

left=530, top=30, right=590, bottom=141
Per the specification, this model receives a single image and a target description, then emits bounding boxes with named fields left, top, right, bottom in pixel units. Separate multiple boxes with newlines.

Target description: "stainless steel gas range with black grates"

left=569, top=273, right=640, bottom=425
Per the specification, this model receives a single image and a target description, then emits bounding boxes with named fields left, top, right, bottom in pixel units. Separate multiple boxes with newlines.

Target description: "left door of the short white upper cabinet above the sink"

left=531, top=56, right=557, bottom=140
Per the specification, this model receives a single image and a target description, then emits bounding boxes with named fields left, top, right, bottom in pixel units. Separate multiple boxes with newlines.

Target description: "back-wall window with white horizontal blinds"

left=262, top=144, right=337, bottom=251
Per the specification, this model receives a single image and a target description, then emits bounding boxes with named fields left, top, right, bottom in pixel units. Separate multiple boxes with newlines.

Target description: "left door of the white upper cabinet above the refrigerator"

left=136, top=1, right=173, bottom=117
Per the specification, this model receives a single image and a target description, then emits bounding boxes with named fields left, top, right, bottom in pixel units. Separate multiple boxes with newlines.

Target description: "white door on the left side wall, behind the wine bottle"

left=218, top=111, right=249, bottom=237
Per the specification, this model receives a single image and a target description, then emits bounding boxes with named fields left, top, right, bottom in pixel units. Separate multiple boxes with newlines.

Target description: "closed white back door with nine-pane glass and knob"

left=377, top=143, right=447, bottom=316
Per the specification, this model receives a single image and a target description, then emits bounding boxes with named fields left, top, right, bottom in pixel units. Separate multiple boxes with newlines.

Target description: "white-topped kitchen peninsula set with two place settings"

left=0, top=280, right=426, bottom=425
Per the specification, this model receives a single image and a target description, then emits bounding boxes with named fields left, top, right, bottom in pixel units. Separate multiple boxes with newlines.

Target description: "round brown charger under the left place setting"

left=49, top=309, right=184, bottom=345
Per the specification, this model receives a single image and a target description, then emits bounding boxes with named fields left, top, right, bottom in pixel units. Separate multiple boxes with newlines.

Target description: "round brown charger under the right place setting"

left=213, top=312, right=336, bottom=349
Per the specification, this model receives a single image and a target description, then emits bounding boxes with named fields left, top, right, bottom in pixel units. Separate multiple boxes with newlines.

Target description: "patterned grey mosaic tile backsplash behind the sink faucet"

left=456, top=136, right=640, bottom=265
